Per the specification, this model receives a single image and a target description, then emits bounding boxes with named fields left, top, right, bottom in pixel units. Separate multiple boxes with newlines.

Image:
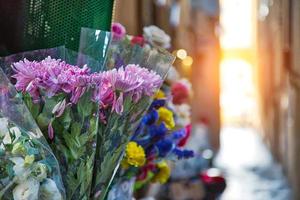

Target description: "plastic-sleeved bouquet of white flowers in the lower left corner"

left=0, top=69, right=65, bottom=200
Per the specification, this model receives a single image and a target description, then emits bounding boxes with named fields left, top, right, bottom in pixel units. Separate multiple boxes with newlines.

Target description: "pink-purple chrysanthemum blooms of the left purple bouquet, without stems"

left=12, top=57, right=90, bottom=103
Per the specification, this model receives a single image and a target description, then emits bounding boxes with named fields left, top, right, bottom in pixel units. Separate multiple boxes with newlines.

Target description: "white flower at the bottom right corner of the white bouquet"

left=40, top=178, right=63, bottom=200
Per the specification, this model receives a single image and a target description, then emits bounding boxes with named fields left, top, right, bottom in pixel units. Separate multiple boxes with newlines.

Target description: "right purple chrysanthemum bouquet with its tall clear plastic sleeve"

left=80, top=27, right=174, bottom=199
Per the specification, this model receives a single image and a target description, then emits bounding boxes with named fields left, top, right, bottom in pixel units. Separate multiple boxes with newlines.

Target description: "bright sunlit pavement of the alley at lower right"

left=215, top=127, right=292, bottom=200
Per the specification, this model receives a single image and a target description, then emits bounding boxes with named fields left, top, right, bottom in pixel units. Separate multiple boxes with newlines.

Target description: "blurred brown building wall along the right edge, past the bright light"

left=257, top=0, right=300, bottom=199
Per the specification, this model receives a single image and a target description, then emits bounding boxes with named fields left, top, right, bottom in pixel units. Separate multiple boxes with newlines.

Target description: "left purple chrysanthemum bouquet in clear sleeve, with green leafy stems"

left=3, top=47, right=100, bottom=199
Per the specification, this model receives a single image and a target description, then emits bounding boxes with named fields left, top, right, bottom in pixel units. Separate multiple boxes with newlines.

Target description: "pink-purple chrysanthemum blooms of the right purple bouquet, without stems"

left=92, top=65, right=162, bottom=114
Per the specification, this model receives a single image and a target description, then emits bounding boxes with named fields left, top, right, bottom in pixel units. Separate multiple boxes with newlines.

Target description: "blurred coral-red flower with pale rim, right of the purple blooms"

left=171, top=82, right=189, bottom=104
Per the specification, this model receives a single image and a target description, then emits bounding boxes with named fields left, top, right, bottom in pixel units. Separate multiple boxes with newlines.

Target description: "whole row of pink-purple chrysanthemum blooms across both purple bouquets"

left=13, top=57, right=162, bottom=114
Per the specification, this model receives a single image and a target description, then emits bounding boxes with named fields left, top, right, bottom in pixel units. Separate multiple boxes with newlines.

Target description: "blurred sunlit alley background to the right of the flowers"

left=113, top=0, right=300, bottom=200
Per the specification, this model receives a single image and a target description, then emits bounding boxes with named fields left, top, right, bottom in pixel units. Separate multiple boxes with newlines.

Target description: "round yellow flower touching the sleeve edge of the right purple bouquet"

left=122, top=142, right=146, bottom=168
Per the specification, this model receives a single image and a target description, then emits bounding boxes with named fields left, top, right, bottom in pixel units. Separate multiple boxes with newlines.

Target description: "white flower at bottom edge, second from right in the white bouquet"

left=13, top=178, right=40, bottom=200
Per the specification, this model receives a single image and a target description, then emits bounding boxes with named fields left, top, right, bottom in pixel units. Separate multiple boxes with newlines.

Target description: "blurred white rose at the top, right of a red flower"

left=143, top=25, right=171, bottom=48
